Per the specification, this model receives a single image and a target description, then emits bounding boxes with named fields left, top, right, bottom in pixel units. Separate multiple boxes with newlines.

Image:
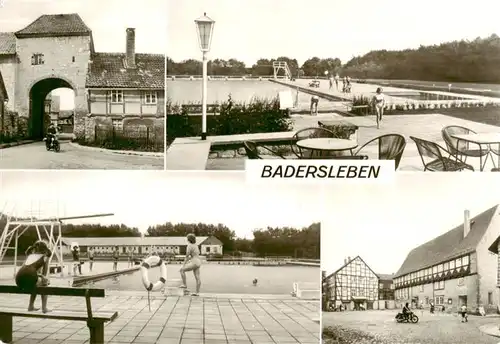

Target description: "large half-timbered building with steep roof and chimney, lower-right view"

left=394, top=206, right=500, bottom=312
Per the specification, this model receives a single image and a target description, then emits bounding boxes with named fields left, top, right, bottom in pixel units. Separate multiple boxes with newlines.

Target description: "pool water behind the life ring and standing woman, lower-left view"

left=81, top=263, right=320, bottom=295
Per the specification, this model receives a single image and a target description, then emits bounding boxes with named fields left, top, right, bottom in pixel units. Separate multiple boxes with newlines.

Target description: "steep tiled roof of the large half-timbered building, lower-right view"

left=394, top=205, right=498, bottom=277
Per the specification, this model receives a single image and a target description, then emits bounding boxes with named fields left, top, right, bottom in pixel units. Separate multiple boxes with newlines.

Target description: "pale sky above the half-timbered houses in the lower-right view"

left=321, top=173, right=500, bottom=274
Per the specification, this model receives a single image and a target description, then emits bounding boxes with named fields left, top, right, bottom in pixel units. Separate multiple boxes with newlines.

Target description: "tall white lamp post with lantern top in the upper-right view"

left=194, top=13, right=215, bottom=140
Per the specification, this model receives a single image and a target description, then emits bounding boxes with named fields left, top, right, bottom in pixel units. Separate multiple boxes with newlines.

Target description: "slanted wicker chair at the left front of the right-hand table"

left=410, top=136, right=474, bottom=172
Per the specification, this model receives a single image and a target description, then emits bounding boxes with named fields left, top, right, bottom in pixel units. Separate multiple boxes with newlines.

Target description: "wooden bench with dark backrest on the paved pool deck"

left=0, top=285, right=118, bottom=344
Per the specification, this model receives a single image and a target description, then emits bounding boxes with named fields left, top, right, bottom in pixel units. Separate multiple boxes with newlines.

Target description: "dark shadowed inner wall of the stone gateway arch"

left=29, top=78, right=74, bottom=140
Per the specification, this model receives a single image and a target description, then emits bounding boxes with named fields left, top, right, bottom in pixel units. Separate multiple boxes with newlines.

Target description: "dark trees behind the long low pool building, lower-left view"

left=0, top=214, right=320, bottom=259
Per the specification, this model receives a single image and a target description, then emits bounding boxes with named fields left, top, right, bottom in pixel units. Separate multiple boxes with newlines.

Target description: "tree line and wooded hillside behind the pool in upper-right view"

left=167, top=34, right=500, bottom=83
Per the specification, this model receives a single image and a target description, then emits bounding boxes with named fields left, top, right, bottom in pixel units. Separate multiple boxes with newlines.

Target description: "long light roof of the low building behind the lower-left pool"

left=62, top=236, right=208, bottom=246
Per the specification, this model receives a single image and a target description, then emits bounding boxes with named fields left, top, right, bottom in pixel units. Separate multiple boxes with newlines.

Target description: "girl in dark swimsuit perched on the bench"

left=16, top=240, right=52, bottom=313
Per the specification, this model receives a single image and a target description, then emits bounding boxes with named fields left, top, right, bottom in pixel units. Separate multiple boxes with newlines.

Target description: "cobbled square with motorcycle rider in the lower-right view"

left=322, top=310, right=500, bottom=344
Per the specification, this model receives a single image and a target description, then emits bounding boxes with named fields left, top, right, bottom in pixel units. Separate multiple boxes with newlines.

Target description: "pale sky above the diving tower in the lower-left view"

left=0, top=170, right=320, bottom=239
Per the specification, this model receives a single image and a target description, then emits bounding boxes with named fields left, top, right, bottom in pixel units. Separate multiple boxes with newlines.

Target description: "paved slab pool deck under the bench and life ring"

left=0, top=291, right=321, bottom=344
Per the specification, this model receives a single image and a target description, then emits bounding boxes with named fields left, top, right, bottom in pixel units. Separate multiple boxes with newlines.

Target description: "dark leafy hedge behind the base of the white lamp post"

left=167, top=96, right=291, bottom=144
